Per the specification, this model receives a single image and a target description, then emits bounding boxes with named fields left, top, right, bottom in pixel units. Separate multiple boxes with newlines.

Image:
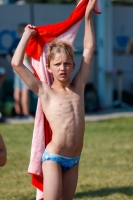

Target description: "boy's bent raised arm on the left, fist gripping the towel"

left=11, top=25, right=41, bottom=95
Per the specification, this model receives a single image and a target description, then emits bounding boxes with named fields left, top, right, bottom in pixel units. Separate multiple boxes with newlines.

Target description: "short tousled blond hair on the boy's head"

left=47, top=40, right=74, bottom=65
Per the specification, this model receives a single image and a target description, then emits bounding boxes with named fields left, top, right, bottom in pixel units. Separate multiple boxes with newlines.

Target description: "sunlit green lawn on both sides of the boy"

left=0, top=117, right=133, bottom=200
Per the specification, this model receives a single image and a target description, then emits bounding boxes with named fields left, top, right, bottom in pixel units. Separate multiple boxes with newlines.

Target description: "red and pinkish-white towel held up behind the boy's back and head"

left=26, top=0, right=101, bottom=200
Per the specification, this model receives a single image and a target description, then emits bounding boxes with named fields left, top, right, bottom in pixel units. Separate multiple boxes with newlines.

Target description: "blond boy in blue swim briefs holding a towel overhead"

left=12, top=0, right=96, bottom=200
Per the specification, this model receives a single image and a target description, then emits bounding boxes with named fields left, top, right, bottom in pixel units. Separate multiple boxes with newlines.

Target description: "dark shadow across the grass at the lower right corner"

left=74, top=186, right=133, bottom=199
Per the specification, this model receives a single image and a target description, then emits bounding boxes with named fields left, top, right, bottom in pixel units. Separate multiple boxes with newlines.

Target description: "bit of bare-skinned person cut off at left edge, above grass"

left=0, top=134, right=7, bottom=167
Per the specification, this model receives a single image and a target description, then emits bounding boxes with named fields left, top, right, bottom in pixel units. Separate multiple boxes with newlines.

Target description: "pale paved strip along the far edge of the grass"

left=2, top=107, right=133, bottom=124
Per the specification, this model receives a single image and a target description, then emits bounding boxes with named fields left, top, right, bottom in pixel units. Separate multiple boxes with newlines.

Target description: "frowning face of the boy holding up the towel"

left=47, top=53, right=75, bottom=82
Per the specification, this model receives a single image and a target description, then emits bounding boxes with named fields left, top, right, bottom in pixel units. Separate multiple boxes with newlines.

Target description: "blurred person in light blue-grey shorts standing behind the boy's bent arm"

left=9, top=23, right=33, bottom=119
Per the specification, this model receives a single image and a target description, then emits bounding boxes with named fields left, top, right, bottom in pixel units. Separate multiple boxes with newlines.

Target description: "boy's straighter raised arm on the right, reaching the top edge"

left=75, top=0, right=96, bottom=85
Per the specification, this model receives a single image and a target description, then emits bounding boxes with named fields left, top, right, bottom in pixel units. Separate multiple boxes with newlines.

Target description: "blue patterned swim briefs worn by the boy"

left=42, top=149, right=80, bottom=172
